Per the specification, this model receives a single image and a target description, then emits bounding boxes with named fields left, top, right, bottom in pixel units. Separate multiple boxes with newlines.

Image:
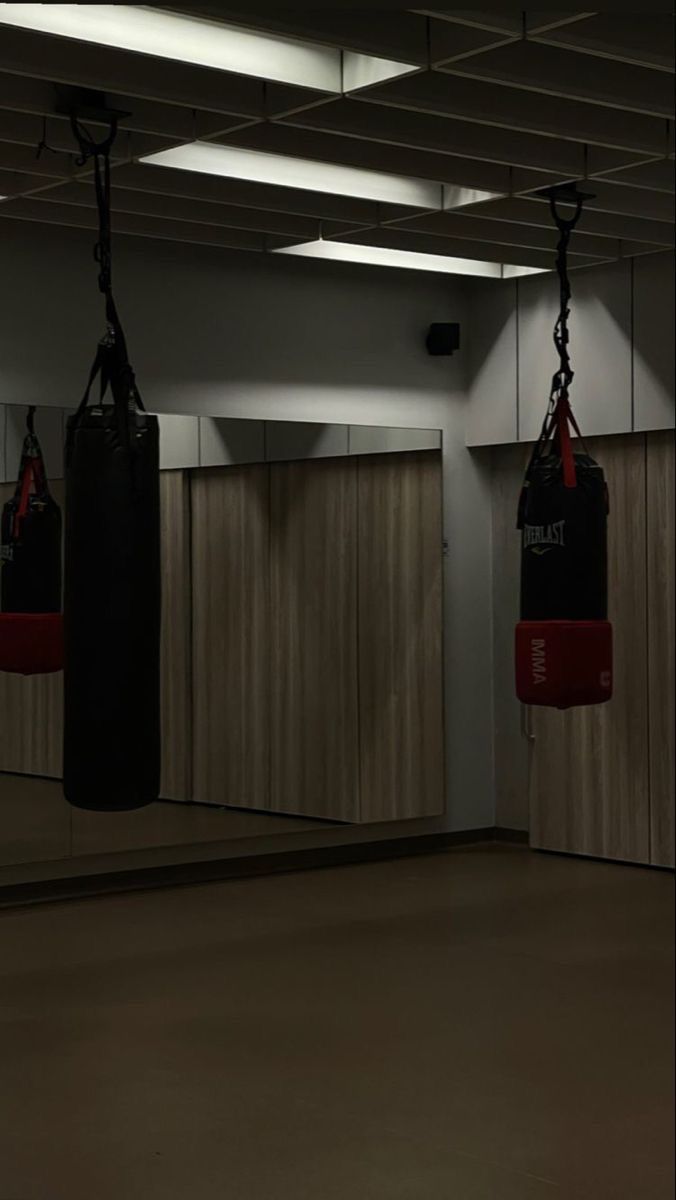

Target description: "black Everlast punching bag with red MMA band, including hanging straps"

left=515, top=194, right=612, bottom=708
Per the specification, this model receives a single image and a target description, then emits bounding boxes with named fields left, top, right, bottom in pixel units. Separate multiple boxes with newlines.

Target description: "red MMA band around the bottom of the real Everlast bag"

left=515, top=620, right=612, bottom=708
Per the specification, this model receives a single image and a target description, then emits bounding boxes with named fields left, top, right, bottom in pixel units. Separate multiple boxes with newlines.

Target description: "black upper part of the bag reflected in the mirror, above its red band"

left=0, top=432, right=61, bottom=613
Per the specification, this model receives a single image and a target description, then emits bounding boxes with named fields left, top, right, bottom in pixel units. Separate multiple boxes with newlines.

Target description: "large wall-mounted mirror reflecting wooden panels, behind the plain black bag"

left=0, top=406, right=444, bottom=884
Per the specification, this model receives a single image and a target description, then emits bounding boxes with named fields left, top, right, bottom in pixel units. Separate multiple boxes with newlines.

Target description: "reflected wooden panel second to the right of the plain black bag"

left=191, top=466, right=269, bottom=809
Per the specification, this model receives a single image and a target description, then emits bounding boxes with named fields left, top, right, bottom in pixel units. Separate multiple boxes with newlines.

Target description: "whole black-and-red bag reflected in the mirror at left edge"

left=0, top=408, right=64, bottom=674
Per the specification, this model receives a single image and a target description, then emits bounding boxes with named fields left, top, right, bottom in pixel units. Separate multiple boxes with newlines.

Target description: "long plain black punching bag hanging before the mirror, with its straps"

left=64, top=114, right=161, bottom=811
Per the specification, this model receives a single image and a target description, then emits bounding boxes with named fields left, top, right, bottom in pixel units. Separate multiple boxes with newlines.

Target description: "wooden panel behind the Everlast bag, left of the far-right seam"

left=530, top=436, right=650, bottom=863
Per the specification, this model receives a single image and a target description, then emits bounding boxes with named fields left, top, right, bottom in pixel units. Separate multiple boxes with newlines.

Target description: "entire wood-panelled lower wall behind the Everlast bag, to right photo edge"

left=530, top=433, right=674, bottom=865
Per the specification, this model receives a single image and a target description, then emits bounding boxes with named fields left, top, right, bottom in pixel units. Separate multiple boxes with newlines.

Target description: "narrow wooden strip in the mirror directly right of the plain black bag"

left=160, top=470, right=192, bottom=800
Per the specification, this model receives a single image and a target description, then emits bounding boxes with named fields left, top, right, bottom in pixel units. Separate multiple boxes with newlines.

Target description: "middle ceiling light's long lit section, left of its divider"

left=139, top=142, right=442, bottom=211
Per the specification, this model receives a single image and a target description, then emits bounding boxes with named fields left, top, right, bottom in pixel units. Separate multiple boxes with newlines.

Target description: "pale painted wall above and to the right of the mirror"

left=0, top=221, right=495, bottom=841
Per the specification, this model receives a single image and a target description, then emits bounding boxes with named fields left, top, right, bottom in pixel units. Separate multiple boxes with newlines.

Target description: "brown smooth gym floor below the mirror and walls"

left=0, top=847, right=674, bottom=1200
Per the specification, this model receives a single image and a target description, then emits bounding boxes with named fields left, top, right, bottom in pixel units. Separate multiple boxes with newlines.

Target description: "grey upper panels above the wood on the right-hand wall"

left=467, top=251, right=675, bottom=445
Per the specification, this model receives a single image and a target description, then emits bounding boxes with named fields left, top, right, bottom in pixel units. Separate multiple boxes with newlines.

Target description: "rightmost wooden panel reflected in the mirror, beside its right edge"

left=358, top=451, right=444, bottom=821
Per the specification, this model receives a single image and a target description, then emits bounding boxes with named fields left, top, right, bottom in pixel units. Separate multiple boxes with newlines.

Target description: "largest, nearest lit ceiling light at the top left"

left=0, top=4, right=418, bottom=94
